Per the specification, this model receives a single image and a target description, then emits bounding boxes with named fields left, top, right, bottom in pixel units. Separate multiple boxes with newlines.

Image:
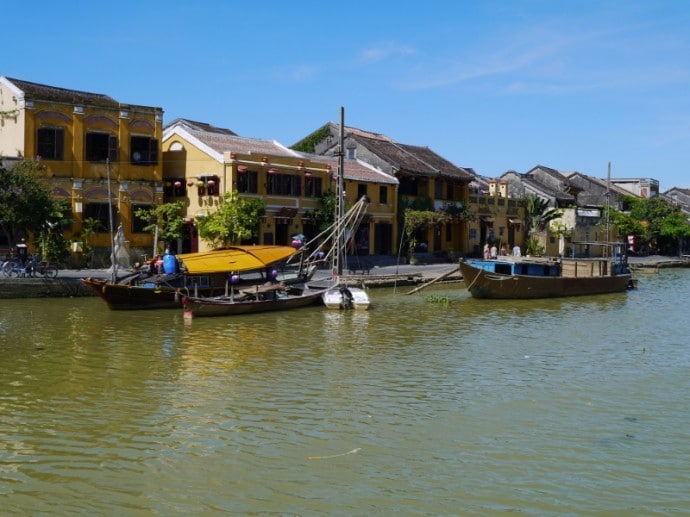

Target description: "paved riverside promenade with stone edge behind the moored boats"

left=0, top=255, right=690, bottom=299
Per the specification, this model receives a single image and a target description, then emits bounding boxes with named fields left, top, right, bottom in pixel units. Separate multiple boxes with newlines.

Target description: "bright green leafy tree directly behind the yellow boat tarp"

left=198, top=192, right=266, bottom=247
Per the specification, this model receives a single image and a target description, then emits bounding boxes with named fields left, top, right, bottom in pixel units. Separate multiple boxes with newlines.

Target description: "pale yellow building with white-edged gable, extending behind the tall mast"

left=162, top=119, right=397, bottom=254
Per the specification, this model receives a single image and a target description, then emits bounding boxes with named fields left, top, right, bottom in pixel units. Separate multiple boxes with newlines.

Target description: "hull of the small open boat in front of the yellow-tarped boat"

left=182, top=288, right=324, bottom=318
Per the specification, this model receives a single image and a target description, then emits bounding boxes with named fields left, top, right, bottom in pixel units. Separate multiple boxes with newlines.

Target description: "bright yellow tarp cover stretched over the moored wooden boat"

left=177, top=245, right=297, bottom=274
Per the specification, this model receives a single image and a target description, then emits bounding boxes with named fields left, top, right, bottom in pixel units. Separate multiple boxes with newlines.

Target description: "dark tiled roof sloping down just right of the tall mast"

left=350, top=135, right=473, bottom=180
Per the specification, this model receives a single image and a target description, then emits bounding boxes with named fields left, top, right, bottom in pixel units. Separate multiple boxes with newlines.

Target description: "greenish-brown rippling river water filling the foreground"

left=0, top=269, right=690, bottom=516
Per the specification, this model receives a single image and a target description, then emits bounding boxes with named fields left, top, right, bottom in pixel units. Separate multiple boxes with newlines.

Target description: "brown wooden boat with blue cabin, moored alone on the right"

left=460, top=243, right=635, bottom=300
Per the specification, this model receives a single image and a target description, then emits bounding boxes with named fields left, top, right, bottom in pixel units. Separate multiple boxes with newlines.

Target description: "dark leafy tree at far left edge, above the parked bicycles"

left=0, top=160, right=64, bottom=250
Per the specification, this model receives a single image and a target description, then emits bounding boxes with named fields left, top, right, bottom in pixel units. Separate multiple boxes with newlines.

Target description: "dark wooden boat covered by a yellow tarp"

left=81, top=245, right=316, bottom=310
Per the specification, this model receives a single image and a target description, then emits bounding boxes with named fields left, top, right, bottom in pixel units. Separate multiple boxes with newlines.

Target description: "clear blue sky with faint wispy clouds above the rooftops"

left=5, top=0, right=690, bottom=191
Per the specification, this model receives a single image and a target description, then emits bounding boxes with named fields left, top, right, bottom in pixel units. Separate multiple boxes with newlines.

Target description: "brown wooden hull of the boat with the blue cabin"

left=460, top=262, right=632, bottom=300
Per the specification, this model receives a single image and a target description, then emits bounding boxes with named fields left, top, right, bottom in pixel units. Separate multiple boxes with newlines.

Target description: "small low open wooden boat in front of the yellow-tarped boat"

left=182, top=283, right=324, bottom=318
